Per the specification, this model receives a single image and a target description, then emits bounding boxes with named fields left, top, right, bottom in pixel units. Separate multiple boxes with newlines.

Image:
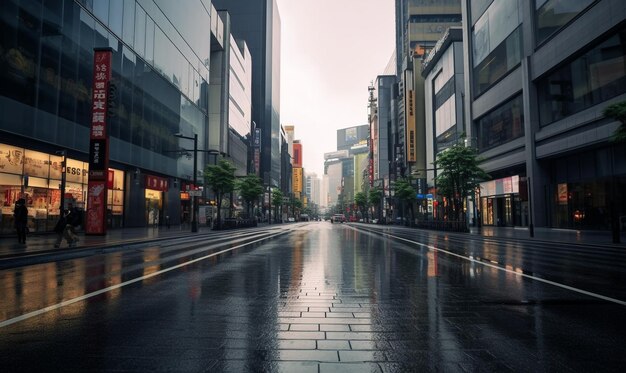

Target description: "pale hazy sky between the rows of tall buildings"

left=277, top=0, right=395, bottom=178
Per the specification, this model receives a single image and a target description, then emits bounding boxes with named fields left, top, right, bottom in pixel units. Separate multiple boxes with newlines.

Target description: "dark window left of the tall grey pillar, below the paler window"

left=476, top=95, right=524, bottom=152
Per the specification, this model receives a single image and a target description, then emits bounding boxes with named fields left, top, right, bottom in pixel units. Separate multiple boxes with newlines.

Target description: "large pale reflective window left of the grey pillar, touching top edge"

left=472, top=1, right=522, bottom=95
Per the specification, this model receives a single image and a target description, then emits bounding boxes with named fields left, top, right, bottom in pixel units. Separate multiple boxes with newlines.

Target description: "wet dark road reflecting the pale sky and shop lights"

left=0, top=222, right=626, bottom=373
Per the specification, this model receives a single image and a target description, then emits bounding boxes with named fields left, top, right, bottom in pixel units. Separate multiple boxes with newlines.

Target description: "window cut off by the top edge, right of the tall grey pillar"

left=535, top=0, right=595, bottom=44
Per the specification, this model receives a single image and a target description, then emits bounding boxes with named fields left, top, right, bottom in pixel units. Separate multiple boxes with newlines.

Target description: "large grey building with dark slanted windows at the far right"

left=463, top=0, right=626, bottom=229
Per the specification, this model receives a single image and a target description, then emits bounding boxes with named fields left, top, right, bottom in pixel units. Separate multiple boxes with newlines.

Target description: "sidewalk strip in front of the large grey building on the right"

left=470, top=226, right=626, bottom=248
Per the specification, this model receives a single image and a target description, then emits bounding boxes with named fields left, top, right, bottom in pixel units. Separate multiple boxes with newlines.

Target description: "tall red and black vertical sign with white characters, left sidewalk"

left=85, top=48, right=113, bottom=234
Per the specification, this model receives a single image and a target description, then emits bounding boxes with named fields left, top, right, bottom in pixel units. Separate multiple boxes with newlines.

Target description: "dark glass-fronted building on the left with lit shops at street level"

left=0, top=0, right=211, bottom=233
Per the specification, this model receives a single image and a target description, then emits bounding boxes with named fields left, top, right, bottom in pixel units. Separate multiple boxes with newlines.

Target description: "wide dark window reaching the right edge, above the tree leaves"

left=537, top=28, right=626, bottom=125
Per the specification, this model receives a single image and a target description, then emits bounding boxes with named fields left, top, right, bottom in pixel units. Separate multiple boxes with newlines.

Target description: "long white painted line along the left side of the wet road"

left=0, top=227, right=297, bottom=328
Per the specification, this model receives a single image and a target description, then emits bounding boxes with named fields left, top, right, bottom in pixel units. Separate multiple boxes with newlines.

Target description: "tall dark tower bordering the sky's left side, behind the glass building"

left=213, top=0, right=281, bottom=186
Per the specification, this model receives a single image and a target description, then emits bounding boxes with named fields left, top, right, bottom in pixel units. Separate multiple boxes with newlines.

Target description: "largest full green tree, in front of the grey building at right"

left=433, top=138, right=490, bottom=221
